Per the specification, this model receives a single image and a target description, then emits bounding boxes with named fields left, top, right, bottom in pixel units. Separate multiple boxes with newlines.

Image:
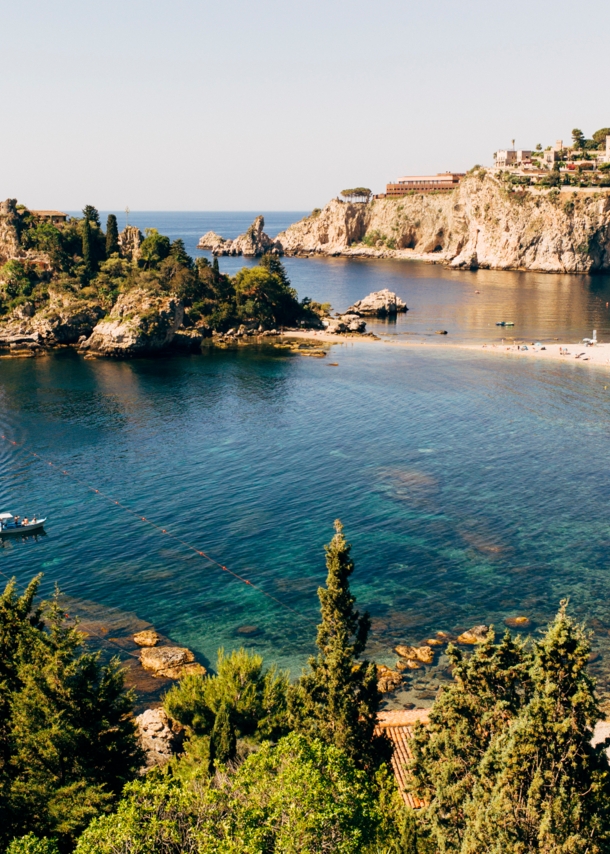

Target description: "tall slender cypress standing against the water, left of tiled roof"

left=291, top=520, right=381, bottom=766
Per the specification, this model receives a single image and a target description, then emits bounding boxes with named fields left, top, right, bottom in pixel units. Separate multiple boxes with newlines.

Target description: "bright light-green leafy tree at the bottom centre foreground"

left=76, top=733, right=394, bottom=854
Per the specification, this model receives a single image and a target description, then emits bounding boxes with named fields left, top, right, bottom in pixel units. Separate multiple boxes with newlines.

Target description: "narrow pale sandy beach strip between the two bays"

left=282, top=330, right=610, bottom=369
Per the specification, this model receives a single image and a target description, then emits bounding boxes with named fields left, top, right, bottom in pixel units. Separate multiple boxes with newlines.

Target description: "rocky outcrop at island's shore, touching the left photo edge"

left=0, top=290, right=104, bottom=347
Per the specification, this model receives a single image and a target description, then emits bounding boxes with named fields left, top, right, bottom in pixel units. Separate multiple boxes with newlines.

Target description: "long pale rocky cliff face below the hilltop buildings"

left=276, top=177, right=610, bottom=273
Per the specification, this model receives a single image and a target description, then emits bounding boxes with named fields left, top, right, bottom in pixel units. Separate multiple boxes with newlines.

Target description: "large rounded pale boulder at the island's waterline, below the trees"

left=82, top=288, right=184, bottom=357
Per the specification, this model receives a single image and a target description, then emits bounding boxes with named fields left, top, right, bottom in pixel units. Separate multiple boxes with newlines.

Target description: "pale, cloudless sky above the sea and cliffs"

left=0, top=0, right=610, bottom=211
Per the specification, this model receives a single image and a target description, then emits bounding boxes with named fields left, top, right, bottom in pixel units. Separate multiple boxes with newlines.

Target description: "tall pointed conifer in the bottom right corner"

left=461, top=602, right=610, bottom=854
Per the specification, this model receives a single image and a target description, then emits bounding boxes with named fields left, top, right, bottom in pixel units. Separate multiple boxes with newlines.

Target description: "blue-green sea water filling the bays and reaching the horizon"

left=0, top=212, right=610, bottom=707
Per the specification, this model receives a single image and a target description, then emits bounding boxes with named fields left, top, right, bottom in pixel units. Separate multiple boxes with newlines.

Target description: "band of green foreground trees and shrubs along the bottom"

left=0, top=523, right=610, bottom=854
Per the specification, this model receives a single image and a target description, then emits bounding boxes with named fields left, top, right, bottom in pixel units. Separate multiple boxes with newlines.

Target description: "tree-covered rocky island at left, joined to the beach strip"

left=0, top=199, right=380, bottom=358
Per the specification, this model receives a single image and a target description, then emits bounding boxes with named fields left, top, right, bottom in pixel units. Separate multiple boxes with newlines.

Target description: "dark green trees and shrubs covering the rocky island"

left=0, top=204, right=317, bottom=331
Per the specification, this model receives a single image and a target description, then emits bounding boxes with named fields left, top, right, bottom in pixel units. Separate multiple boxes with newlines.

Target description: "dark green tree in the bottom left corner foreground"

left=0, top=576, right=141, bottom=849
